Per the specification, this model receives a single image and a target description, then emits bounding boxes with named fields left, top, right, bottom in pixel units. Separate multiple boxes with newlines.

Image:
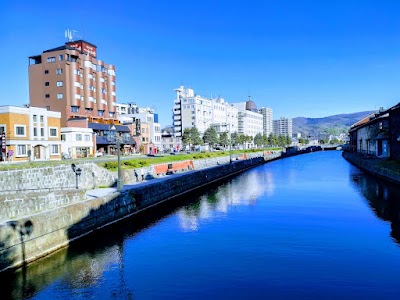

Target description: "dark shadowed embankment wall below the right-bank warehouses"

left=343, top=151, right=400, bottom=184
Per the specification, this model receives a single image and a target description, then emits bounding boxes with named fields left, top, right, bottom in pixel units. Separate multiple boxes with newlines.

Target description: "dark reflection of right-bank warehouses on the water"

left=350, top=171, right=400, bottom=244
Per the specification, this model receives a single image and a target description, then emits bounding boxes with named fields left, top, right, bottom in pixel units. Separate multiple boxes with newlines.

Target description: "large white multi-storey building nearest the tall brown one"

left=173, top=86, right=238, bottom=137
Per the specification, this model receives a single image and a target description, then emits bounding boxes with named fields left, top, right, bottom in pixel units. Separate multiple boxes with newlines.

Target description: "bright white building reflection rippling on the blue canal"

left=178, top=171, right=274, bottom=231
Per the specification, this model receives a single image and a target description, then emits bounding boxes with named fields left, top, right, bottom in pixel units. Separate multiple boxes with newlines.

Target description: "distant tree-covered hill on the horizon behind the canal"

left=293, top=111, right=374, bottom=138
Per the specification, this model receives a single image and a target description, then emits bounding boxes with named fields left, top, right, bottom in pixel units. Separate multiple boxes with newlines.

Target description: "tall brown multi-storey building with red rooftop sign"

left=29, top=40, right=118, bottom=127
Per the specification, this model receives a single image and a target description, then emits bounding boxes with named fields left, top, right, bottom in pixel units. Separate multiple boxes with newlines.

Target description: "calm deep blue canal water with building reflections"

left=0, top=151, right=400, bottom=299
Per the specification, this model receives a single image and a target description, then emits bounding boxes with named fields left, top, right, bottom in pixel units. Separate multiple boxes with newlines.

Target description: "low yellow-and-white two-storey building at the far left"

left=0, top=106, right=61, bottom=161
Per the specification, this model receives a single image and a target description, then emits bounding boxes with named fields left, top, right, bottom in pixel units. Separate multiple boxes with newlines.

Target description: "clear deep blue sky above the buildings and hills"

left=0, top=0, right=400, bottom=126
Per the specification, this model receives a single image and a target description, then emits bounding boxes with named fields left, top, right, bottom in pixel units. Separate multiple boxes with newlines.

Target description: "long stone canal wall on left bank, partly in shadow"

left=0, top=154, right=279, bottom=271
